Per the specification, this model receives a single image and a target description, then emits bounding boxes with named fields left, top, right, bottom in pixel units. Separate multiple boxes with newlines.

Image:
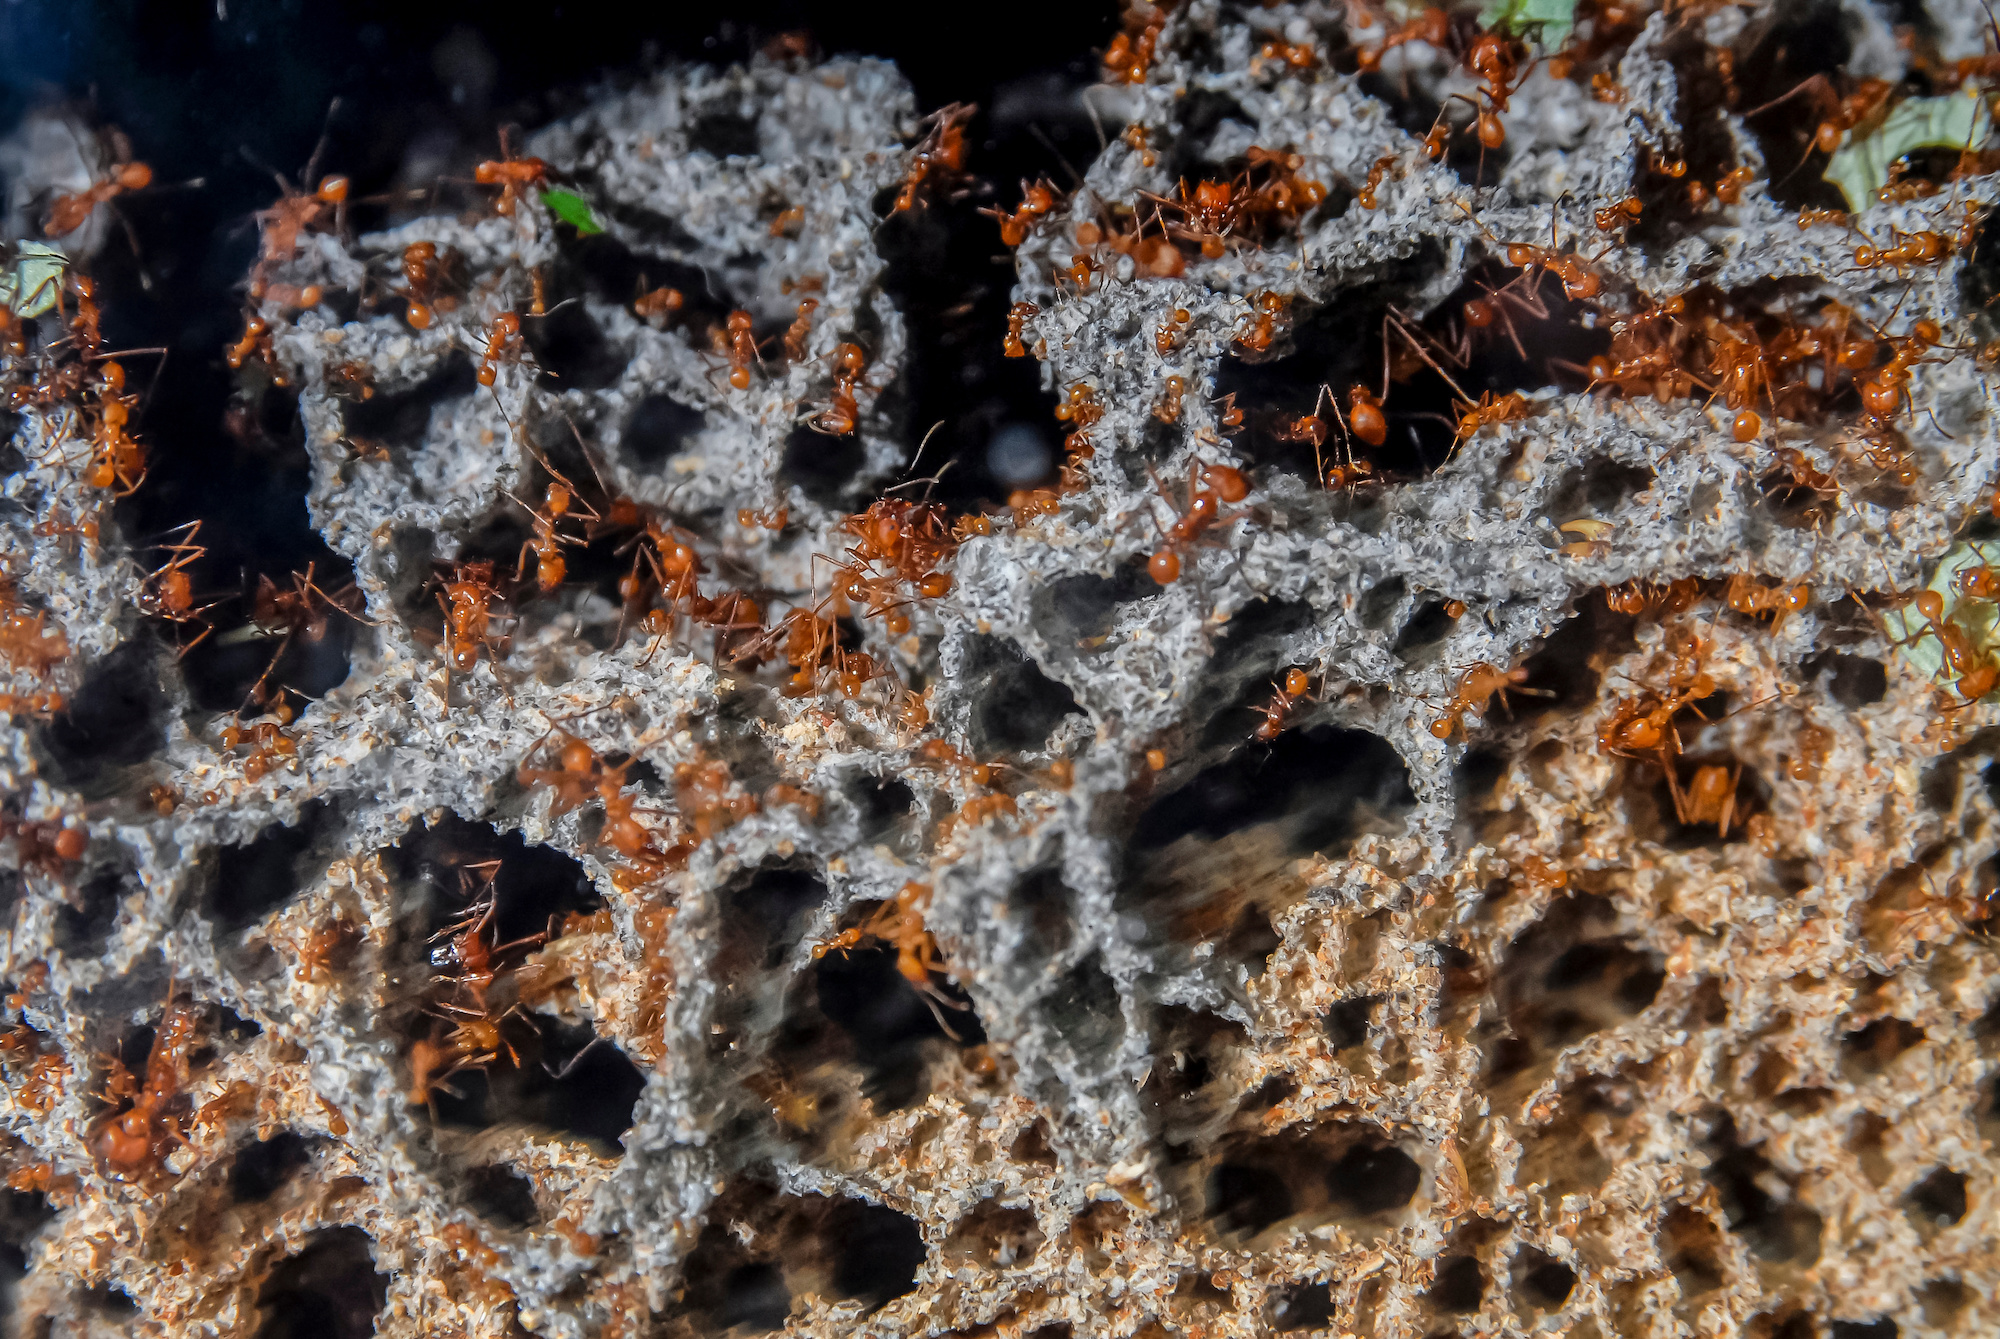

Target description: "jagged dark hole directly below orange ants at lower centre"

left=796, top=945, right=986, bottom=1111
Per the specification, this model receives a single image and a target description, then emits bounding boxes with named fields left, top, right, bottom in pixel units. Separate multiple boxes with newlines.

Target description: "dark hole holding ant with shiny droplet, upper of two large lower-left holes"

left=384, top=813, right=604, bottom=953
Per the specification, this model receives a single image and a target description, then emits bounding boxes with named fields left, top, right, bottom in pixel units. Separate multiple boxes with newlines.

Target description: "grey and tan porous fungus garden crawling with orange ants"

left=0, top=0, right=2000, bottom=1339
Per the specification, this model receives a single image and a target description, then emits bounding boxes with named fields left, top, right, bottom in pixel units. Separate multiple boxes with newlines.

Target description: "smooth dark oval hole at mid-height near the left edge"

left=32, top=638, right=166, bottom=799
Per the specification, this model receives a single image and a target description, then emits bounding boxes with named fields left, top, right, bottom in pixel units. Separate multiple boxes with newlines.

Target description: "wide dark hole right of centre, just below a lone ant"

left=1132, top=725, right=1416, bottom=853
